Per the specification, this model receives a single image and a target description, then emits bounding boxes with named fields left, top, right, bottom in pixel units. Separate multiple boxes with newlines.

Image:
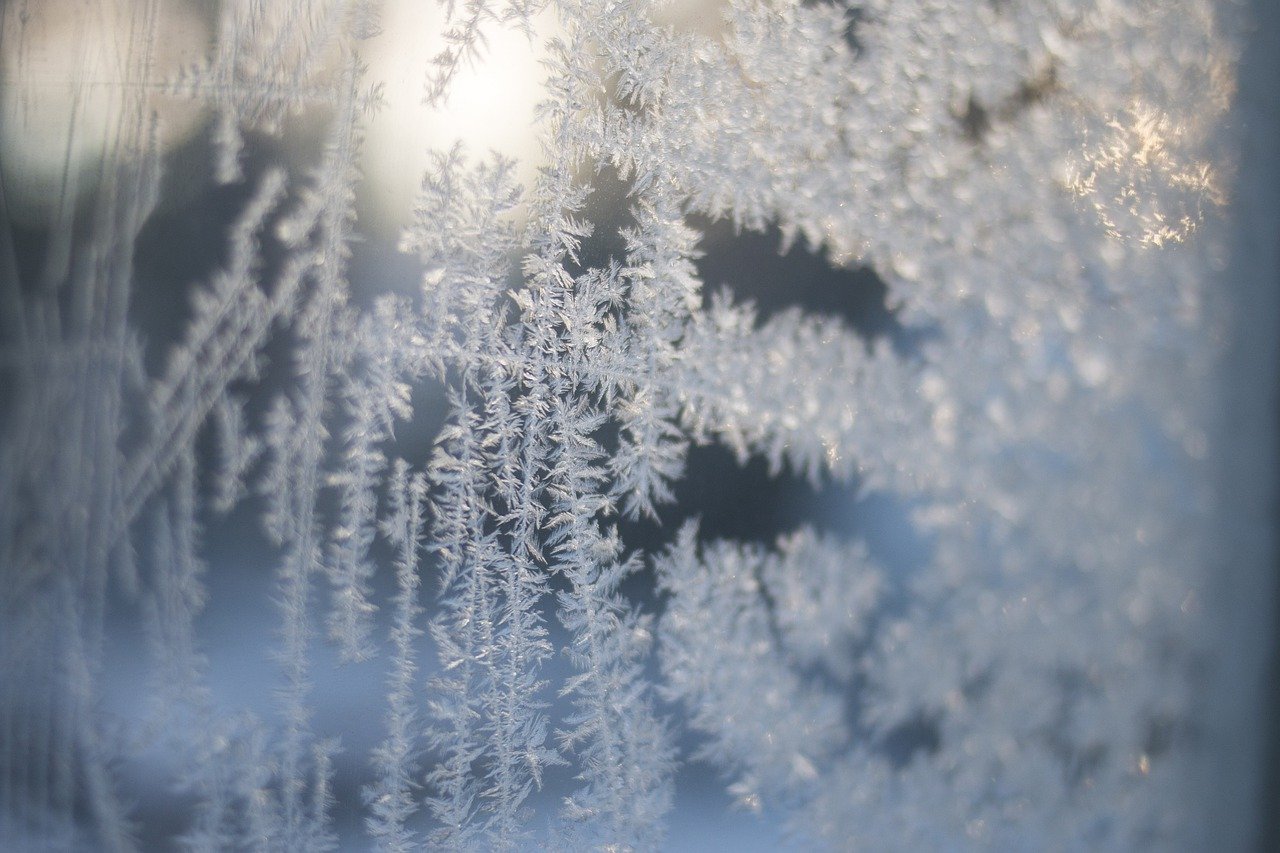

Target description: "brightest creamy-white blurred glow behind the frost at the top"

left=361, top=0, right=559, bottom=236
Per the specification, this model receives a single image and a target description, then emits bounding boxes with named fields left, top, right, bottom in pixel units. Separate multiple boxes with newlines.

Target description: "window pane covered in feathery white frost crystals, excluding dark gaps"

left=0, top=0, right=1264, bottom=850
